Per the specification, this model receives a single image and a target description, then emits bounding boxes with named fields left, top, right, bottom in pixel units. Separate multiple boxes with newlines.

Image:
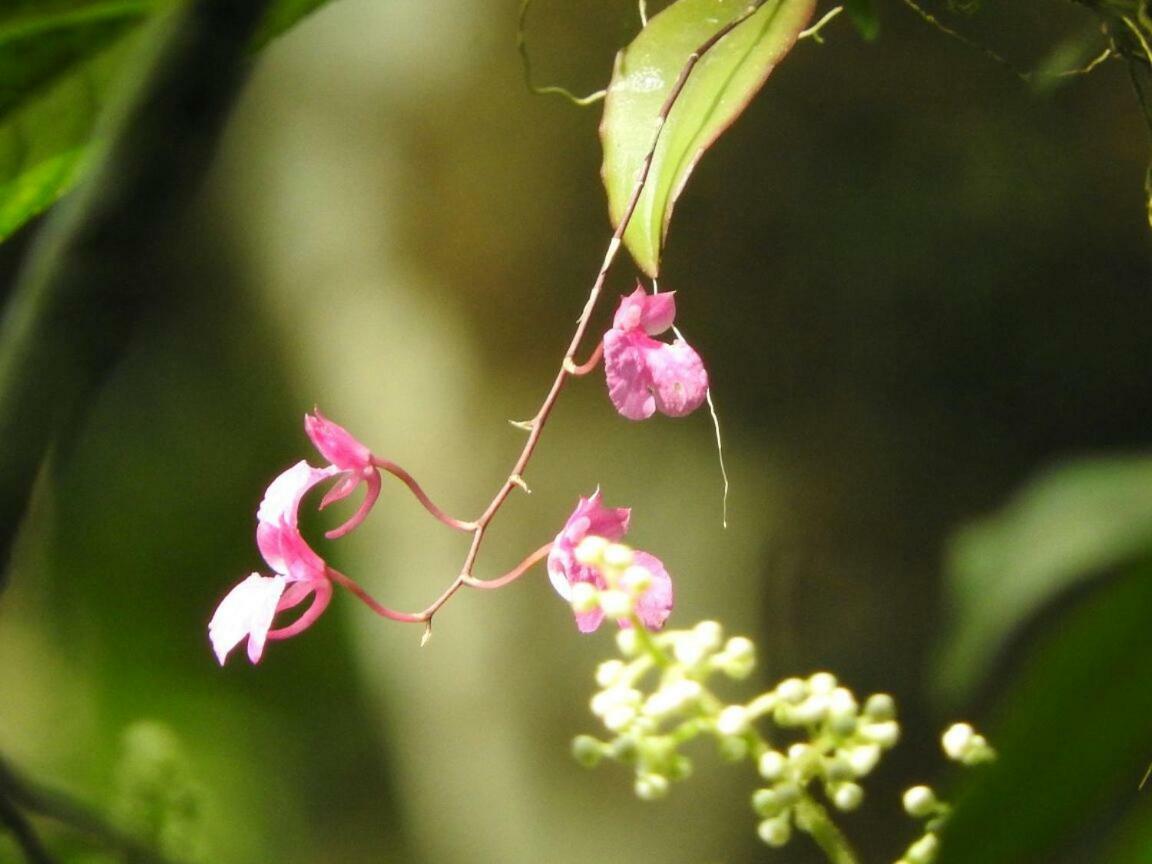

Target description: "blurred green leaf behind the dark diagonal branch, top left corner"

left=0, top=0, right=340, bottom=240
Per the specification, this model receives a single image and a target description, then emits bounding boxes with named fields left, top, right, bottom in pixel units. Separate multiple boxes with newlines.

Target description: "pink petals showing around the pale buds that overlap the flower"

left=548, top=490, right=673, bottom=632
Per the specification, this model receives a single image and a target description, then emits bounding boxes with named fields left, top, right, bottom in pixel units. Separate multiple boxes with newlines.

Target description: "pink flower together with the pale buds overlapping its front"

left=548, top=490, right=673, bottom=632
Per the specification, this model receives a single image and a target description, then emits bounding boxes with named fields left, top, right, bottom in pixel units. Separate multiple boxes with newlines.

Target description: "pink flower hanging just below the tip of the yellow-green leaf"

left=604, top=285, right=708, bottom=420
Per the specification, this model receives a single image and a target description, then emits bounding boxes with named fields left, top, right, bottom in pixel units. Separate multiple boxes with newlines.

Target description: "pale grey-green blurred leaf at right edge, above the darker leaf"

left=940, top=456, right=1152, bottom=694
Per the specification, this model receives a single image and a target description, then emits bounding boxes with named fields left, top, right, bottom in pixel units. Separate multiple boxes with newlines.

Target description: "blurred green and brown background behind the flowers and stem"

left=0, top=0, right=1152, bottom=864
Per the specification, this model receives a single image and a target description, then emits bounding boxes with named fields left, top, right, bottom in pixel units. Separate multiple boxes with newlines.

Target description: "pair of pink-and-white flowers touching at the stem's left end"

left=209, top=411, right=380, bottom=665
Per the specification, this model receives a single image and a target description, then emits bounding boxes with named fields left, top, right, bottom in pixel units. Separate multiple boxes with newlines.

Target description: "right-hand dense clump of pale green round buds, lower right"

left=750, top=672, right=900, bottom=847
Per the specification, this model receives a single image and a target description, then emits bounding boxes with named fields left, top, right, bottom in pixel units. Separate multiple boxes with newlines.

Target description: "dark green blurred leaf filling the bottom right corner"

left=937, top=560, right=1152, bottom=864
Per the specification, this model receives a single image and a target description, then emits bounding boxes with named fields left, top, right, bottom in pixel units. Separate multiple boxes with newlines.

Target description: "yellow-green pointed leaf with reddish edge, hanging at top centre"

left=600, top=0, right=816, bottom=276
